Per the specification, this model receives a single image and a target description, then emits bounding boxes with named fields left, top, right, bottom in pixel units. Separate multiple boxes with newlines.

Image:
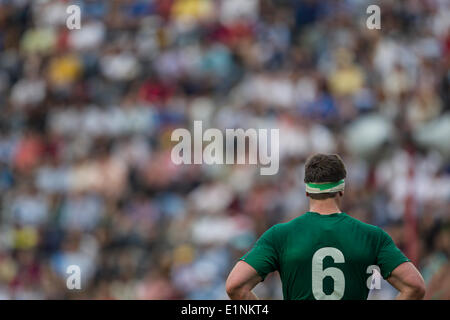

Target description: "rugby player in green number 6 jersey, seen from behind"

left=226, top=154, right=425, bottom=300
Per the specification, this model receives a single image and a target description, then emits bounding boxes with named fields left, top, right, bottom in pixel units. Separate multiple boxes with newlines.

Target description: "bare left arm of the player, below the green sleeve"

left=225, top=261, right=262, bottom=300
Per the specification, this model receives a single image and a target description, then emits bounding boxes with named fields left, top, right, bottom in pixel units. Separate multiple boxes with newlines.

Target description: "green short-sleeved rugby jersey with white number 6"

left=240, top=212, right=410, bottom=300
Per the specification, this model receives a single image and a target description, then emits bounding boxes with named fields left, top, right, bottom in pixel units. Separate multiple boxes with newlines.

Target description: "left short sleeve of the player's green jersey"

left=239, top=226, right=278, bottom=280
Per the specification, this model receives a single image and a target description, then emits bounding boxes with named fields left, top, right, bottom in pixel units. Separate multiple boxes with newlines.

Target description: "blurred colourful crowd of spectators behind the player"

left=0, top=0, right=450, bottom=299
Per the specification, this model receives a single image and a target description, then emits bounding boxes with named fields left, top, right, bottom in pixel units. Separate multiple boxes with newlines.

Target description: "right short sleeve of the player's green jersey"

left=377, top=229, right=411, bottom=279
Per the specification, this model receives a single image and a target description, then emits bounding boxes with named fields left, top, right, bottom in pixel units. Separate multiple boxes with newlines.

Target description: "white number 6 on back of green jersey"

left=312, top=247, right=345, bottom=300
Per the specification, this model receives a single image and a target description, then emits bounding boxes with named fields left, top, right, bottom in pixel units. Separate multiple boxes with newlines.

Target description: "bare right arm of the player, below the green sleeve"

left=387, top=262, right=425, bottom=300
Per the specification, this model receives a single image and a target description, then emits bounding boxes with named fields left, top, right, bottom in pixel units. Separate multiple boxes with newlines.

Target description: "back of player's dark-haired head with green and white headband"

left=304, top=153, right=347, bottom=200
